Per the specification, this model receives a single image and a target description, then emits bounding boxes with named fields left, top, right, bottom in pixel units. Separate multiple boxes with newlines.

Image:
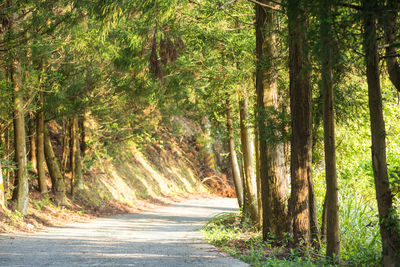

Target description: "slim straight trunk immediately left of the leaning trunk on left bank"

left=36, top=93, right=49, bottom=195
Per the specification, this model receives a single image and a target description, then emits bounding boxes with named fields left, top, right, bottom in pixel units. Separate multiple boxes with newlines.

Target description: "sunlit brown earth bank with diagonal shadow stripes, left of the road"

left=0, top=117, right=234, bottom=232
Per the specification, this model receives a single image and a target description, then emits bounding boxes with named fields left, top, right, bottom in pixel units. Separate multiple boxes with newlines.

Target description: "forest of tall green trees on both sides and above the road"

left=0, top=0, right=400, bottom=266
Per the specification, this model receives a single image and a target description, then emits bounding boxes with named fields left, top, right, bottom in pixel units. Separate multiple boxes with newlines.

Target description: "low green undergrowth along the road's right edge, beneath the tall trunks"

left=202, top=208, right=380, bottom=267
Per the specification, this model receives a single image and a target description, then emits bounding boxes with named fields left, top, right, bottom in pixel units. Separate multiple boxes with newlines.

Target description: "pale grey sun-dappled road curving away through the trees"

left=0, top=198, right=248, bottom=267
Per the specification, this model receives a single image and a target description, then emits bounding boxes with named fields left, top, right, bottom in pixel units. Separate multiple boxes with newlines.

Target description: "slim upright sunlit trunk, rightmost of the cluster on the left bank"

left=71, top=114, right=83, bottom=195
